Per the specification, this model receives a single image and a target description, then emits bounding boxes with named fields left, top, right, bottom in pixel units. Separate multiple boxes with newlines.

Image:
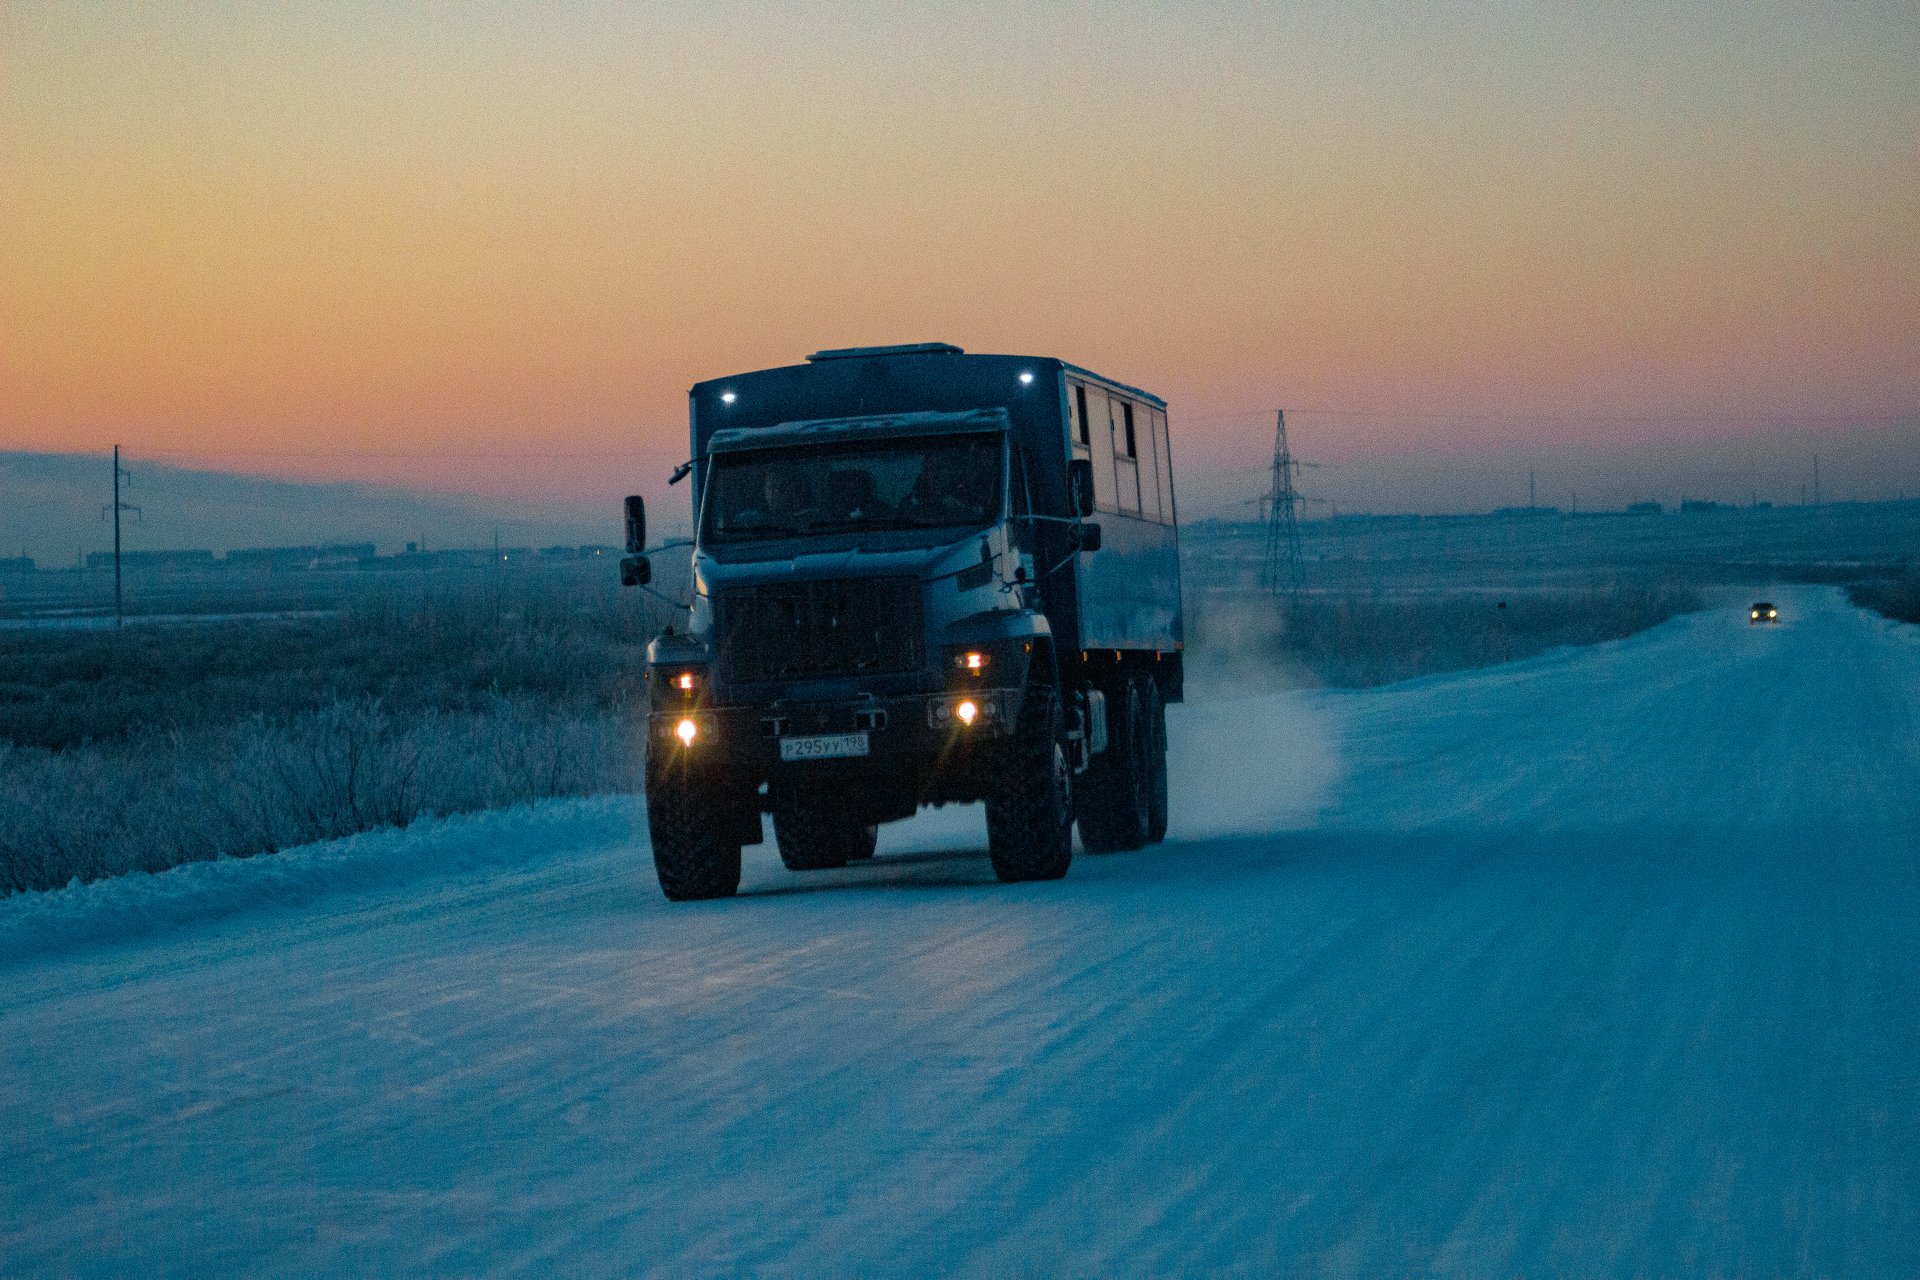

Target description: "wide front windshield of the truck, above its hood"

left=701, top=432, right=1000, bottom=543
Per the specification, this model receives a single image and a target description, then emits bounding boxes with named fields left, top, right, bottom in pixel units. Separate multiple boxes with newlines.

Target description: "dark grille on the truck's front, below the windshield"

left=714, top=578, right=922, bottom=681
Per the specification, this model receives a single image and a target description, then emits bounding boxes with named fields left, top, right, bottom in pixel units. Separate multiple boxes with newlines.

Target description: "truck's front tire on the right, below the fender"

left=987, top=685, right=1073, bottom=881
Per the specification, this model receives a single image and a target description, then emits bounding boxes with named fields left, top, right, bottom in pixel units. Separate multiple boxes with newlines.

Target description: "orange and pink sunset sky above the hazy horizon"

left=0, top=0, right=1920, bottom=514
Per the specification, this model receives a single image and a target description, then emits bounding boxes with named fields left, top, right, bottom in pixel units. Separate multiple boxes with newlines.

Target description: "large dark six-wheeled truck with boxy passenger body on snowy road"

left=620, top=344, right=1185, bottom=902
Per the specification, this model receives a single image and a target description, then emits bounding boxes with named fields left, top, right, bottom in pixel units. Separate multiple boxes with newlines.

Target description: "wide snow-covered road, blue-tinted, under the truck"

left=0, top=589, right=1920, bottom=1276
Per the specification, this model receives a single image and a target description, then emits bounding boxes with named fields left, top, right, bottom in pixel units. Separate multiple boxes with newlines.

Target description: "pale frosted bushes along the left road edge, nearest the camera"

left=0, top=695, right=643, bottom=892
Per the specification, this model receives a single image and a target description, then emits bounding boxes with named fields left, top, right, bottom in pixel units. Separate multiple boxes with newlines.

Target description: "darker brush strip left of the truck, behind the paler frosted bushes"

left=0, top=570, right=666, bottom=748
